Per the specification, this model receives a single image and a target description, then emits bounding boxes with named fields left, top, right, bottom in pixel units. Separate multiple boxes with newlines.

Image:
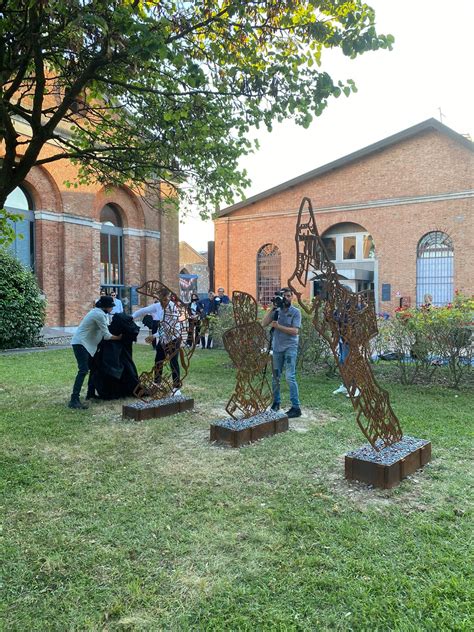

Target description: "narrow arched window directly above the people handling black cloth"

left=100, top=204, right=123, bottom=287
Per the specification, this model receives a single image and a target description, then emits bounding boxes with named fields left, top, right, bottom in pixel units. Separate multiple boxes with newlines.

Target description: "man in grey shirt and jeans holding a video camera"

left=262, top=287, right=301, bottom=419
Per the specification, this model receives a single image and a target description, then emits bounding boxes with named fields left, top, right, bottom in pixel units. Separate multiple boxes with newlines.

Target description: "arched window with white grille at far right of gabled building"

left=416, top=230, right=454, bottom=306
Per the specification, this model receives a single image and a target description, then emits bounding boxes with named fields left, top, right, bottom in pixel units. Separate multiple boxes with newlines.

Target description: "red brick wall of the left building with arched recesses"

left=7, top=145, right=179, bottom=326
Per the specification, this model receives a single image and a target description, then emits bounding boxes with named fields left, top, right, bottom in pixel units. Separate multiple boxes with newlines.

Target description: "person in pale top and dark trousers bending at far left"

left=68, top=296, right=122, bottom=409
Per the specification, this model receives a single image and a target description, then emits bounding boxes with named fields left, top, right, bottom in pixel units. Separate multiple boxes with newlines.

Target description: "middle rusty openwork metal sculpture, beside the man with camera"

left=223, top=292, right=272, bottom=419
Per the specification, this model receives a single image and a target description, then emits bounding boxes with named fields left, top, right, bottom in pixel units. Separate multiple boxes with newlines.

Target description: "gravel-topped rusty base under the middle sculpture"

left=210, top=411, right=288, bottom=448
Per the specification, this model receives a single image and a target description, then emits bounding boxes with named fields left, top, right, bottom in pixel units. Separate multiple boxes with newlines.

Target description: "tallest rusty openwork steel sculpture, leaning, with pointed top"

left=288, top=197, right=403, bottom=450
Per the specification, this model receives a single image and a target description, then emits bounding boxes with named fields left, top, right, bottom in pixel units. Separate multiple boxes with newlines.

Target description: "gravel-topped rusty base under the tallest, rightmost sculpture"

left=345, top=436, right=431, bottom=489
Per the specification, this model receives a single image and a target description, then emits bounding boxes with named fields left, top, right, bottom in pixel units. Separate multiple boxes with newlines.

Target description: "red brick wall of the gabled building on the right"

left=215, top=131, right=474, bottom=310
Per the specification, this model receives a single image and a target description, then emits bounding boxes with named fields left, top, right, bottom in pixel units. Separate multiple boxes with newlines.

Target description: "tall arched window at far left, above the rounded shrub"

left=5, top=187, right=35, bottom=271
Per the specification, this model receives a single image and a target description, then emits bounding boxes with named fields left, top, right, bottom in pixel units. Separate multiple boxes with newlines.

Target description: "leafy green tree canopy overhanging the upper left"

left=0, top=0, right=393, bottom=237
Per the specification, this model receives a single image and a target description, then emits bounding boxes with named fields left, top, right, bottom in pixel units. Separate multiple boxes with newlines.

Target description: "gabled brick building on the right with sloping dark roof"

left=215, top=119, right=474, bottom=312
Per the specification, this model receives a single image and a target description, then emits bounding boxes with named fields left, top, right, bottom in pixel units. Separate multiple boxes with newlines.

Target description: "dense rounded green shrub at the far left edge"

left=0, top=248, right=45, bottom=349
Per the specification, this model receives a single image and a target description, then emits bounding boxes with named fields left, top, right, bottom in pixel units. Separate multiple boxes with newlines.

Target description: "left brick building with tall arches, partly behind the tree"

left=5, top=123, right=178, bottom=326
